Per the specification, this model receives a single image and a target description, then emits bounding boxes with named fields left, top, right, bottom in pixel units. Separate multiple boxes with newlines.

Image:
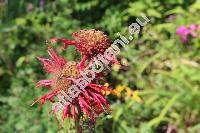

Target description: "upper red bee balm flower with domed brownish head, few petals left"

left=52, top=29, right=115, bottom=68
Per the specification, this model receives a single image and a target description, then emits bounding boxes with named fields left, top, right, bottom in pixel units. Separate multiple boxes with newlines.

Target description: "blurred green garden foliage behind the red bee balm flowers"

left=0, top=0, right=200, bottom=133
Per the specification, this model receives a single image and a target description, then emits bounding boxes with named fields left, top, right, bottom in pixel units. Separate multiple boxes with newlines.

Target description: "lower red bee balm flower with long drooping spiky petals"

left=32, top=47, right=109, bottom=123
